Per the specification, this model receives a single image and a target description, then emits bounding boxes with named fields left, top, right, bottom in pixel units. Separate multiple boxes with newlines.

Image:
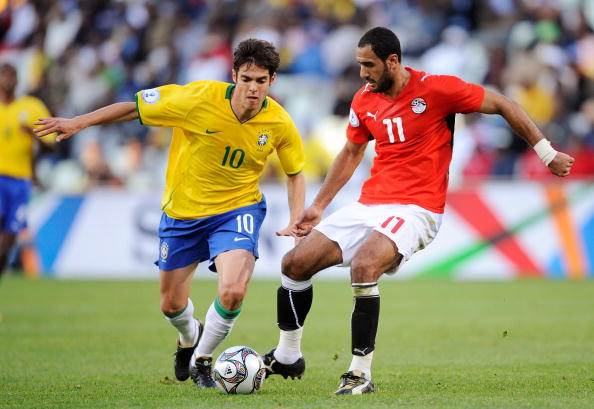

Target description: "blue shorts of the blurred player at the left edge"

left=0, top=175, right=31, bottom=234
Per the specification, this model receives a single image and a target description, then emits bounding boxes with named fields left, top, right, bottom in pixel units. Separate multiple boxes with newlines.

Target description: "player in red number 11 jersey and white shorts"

left=264, top=27, right=574, bottom=395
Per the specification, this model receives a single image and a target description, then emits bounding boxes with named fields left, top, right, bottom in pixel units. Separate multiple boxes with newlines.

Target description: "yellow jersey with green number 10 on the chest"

left=136, top=81, right=305, bottom=219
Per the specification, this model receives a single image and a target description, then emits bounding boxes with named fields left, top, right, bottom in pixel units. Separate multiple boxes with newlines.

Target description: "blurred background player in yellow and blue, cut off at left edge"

left=0, top=63, right=51, bottom=276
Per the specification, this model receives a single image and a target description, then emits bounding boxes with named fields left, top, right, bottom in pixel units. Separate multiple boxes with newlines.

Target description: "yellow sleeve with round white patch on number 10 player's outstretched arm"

left=136, top=84, right=193, bottom=128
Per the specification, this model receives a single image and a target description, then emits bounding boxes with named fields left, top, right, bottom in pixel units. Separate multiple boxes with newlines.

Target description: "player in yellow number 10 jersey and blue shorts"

left=36, top=39, right=305, bottom=387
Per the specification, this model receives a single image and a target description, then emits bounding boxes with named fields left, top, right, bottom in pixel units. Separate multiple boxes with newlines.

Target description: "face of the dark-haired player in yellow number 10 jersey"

left=233, top=64, right=276, bottom=111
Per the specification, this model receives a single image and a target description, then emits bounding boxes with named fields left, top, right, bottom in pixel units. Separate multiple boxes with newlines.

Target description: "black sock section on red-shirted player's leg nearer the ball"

left=276, top=286, right=313, bottom=331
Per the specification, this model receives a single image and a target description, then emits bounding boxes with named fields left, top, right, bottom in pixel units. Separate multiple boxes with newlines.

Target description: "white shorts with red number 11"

left=314, top=202, right=443, bottom=274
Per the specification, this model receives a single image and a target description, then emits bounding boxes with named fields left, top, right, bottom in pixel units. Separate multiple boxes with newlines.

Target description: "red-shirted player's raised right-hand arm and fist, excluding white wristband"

left=479, top=89, right=575, bottom=176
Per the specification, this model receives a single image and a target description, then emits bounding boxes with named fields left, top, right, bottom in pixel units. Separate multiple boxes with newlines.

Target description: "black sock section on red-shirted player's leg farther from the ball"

left=351, top=294, right=380, bottom=356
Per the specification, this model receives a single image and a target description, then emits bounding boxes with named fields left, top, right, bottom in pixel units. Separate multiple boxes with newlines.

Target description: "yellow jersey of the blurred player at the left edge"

left=0, top=96, right=54, bottom=179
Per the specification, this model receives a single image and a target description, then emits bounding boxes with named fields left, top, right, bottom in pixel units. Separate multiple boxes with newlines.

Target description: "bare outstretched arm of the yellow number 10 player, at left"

left=33, top=102, right=138, bottom=141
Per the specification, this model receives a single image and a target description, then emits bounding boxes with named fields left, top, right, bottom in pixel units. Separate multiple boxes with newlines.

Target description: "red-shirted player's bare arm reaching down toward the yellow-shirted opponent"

left=295, top=140, right=367, bottom=236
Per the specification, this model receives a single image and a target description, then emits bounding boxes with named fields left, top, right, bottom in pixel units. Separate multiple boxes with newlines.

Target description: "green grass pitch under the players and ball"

left=0, top=277, right=594, bottom=409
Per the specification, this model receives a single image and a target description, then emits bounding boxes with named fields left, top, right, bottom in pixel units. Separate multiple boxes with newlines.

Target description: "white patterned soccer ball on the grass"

left=212, top=346, right=266, bottom=394
